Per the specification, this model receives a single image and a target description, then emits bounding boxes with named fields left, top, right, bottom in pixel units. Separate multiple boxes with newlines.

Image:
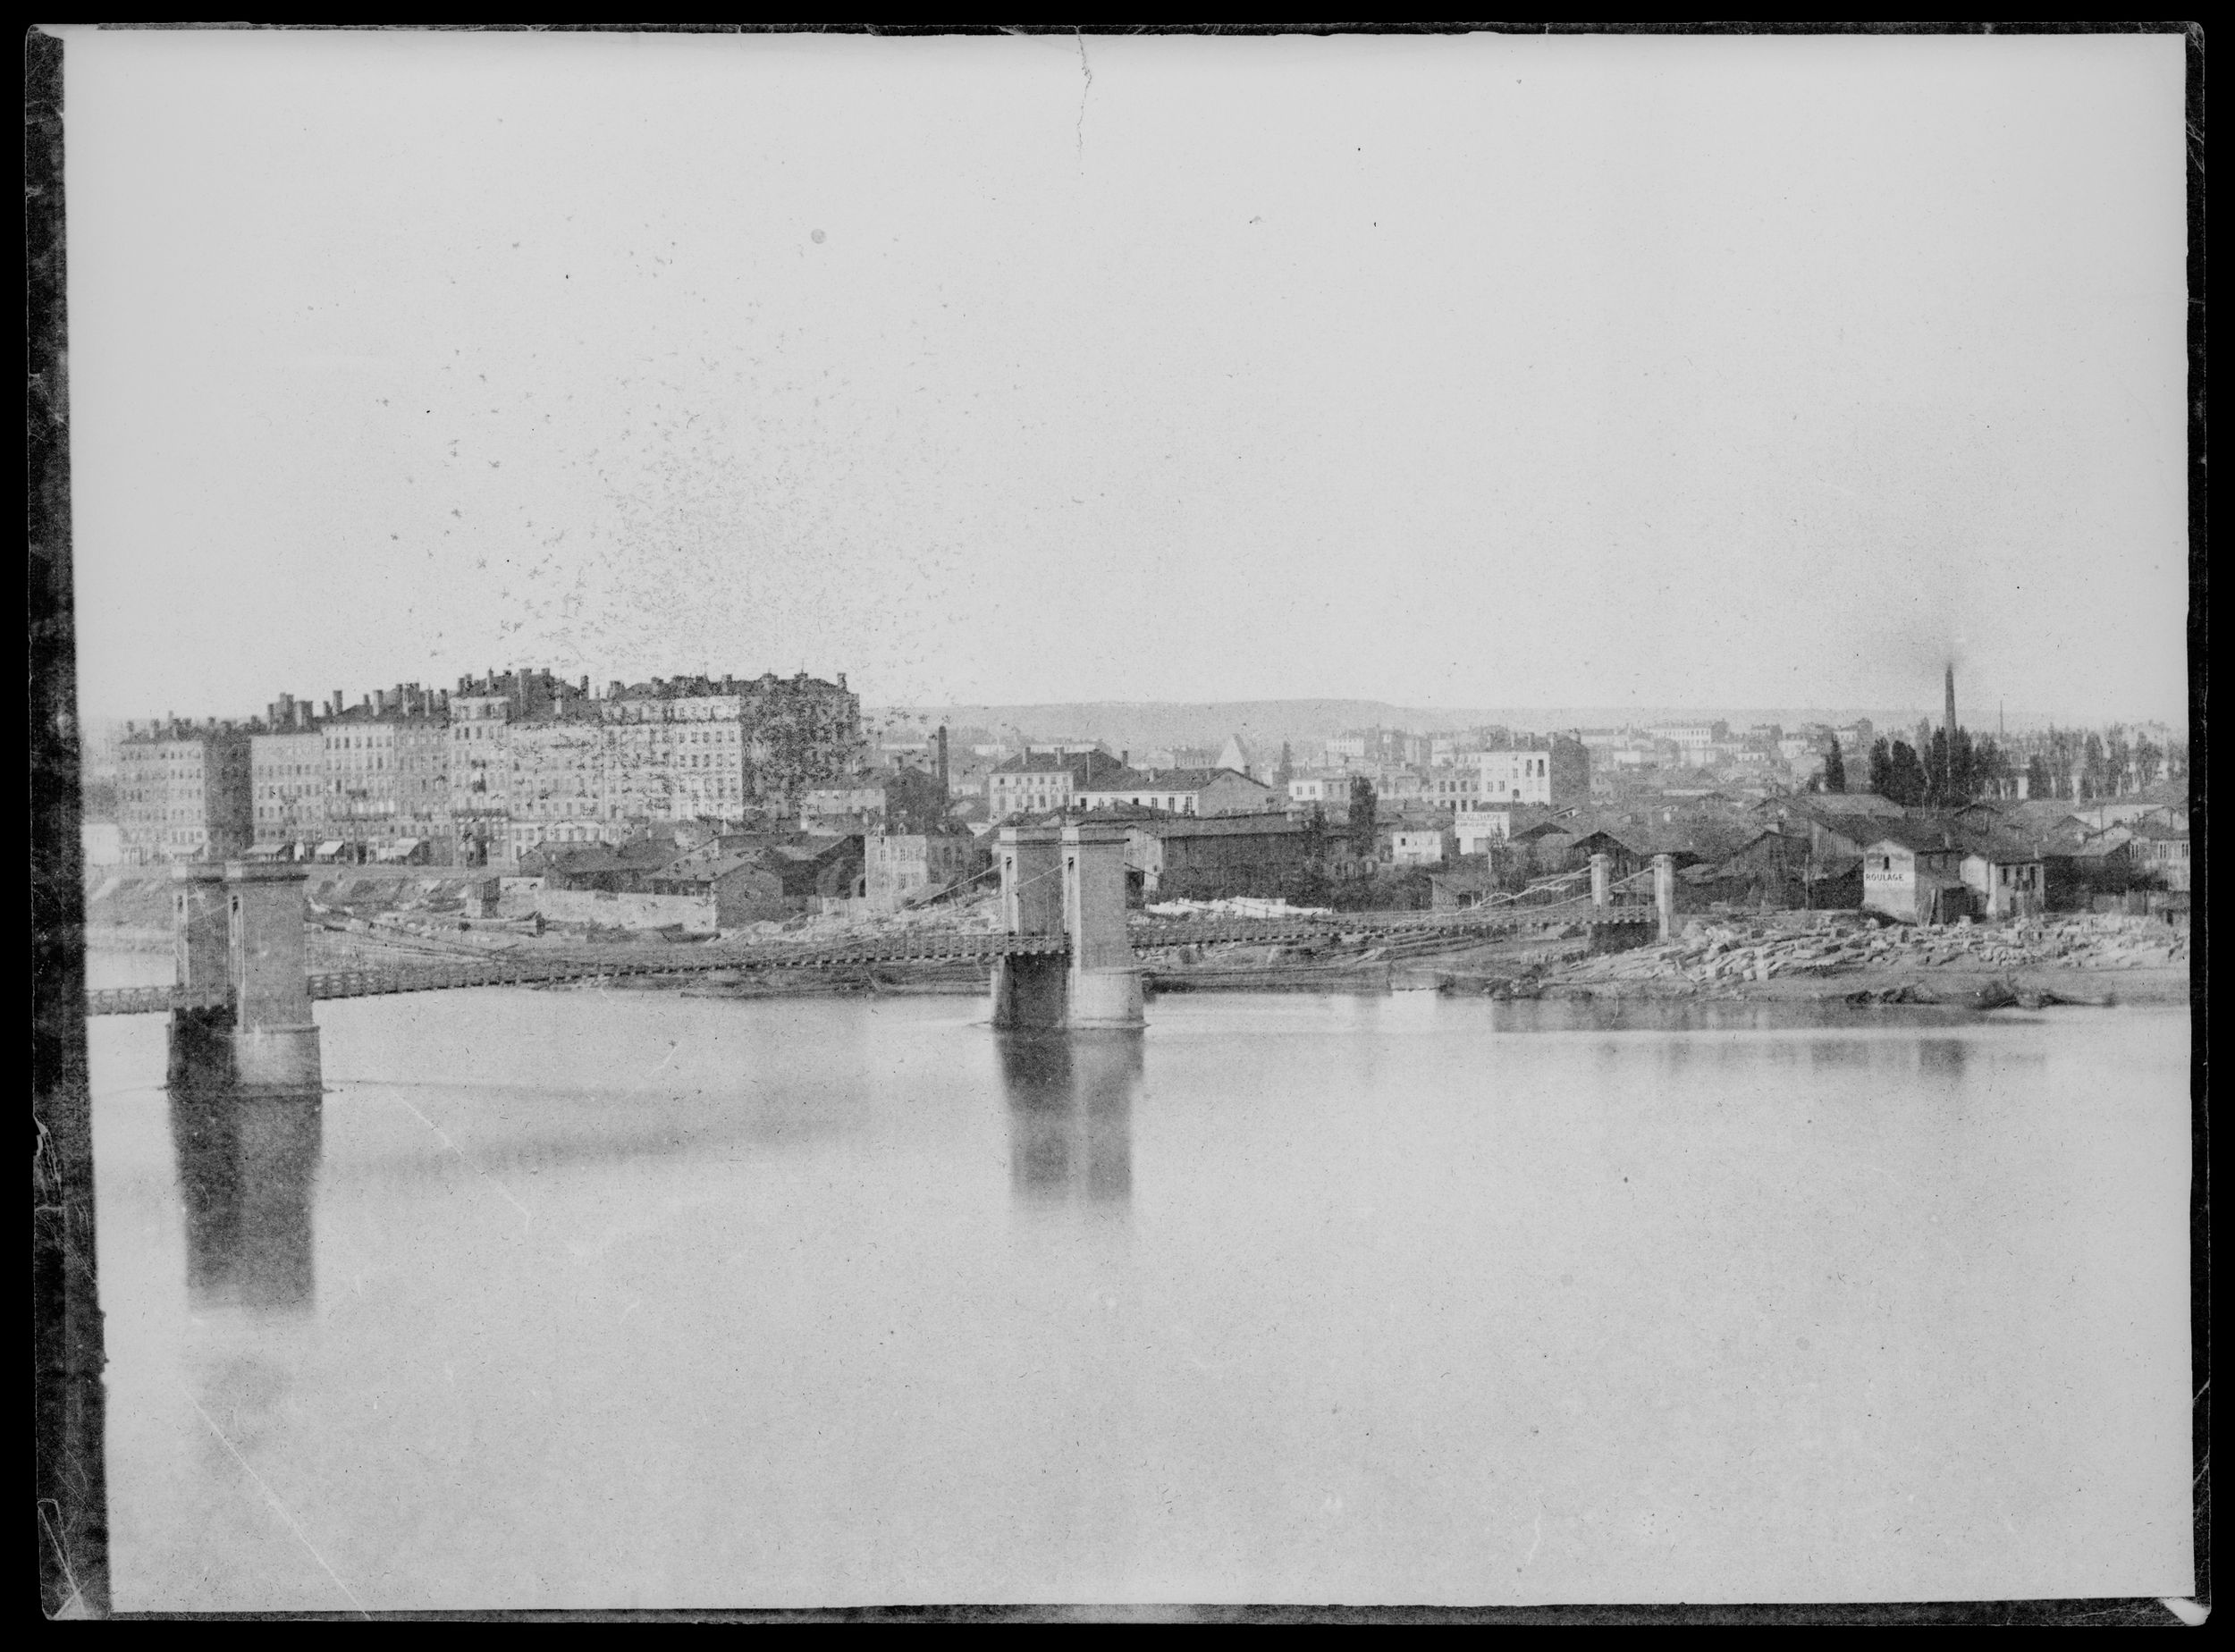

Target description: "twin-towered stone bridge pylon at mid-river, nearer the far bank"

left=992, top=821, right=1143, bottom=1031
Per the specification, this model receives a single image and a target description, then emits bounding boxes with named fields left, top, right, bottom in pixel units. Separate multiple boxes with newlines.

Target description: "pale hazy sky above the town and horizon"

left=58, top=30, right=2189, bottom=722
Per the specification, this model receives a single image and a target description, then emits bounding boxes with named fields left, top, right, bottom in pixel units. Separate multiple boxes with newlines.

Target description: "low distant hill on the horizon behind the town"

left=863, top=700, right=1967, bottom=749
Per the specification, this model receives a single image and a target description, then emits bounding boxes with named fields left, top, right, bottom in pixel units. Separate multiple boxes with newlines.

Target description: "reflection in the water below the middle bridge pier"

left=999, top=1032, right=1140, bottom=1214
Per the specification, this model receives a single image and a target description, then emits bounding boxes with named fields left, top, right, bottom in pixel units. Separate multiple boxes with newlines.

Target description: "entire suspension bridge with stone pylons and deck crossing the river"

left=88, top=822, right=1674, bottom=1041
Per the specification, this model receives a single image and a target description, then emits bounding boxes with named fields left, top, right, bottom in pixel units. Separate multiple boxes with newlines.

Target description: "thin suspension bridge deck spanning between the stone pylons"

left=85, top=898, right=1654, bottom=1015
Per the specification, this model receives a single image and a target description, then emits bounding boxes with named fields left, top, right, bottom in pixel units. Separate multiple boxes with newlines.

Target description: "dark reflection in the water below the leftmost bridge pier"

left=170, top=1086, right=322, bottom=1312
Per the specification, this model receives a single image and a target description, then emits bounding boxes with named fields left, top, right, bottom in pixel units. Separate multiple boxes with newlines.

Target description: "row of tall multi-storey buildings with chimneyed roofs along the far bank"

left=116, top=670, right=863, bottom=865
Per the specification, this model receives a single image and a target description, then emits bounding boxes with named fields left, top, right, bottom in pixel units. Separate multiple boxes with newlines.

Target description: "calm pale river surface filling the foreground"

left=92, top=961, right=2190, bottom=1609
